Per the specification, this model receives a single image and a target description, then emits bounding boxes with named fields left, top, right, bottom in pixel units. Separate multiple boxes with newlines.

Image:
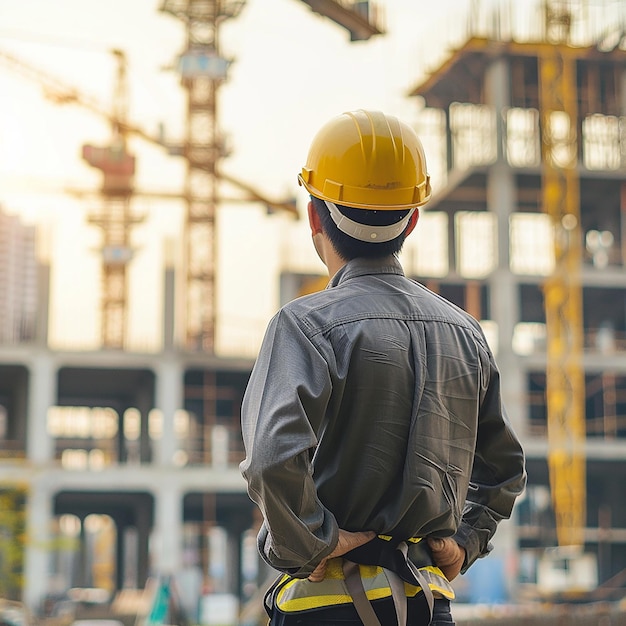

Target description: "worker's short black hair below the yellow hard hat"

left=311, top=196, right=410, bottom=261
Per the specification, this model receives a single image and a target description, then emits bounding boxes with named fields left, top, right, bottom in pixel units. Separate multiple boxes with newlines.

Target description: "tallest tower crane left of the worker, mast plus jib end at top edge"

left=160, top=0, right=382, bottom=352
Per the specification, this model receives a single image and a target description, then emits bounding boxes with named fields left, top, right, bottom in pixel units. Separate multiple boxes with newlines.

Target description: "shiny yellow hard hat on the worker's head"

left=298, top=110, right=431, bottom=210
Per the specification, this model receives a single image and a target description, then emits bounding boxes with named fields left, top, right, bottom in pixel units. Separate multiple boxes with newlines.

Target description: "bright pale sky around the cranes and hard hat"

left=0, top=0, right=498, bottom=354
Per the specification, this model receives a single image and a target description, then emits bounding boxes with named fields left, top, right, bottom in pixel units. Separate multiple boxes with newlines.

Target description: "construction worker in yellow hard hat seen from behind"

left=241, top=110, right=526, bottom=626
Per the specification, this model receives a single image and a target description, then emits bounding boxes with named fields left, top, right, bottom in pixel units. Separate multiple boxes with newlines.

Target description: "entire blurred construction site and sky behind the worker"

left=0, top=0, right=626, bottom=626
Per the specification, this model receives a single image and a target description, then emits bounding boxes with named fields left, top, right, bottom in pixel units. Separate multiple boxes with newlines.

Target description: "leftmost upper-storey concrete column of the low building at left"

left=26, top=351, right=57, bottom=465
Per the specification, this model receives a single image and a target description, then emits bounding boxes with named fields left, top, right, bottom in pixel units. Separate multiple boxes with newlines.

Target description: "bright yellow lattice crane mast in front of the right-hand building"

left=539, top=2, right=586, bottom=548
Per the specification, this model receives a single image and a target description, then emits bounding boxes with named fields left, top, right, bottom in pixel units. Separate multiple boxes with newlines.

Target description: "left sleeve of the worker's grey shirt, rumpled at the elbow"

left=240, top=309, right=338, bottom=578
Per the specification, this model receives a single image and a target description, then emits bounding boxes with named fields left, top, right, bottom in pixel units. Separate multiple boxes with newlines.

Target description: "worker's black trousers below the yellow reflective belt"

left=269, top=594, right=454, bottom=626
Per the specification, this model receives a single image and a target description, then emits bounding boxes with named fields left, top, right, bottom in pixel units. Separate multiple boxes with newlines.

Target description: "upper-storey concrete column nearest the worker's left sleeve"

left=155, top=355, right=184, bottom=466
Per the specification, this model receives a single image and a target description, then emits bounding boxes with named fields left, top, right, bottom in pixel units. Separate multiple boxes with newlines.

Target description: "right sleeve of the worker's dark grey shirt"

left=454, top=346, right=526, bottom=573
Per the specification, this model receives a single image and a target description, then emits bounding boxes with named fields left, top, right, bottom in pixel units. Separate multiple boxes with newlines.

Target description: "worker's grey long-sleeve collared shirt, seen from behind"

left=241, top=257, right=526, bottom=577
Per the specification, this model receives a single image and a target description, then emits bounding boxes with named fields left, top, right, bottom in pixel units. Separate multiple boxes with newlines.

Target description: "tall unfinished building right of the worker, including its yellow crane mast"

left=411, top=3, right=626, bottom=597
